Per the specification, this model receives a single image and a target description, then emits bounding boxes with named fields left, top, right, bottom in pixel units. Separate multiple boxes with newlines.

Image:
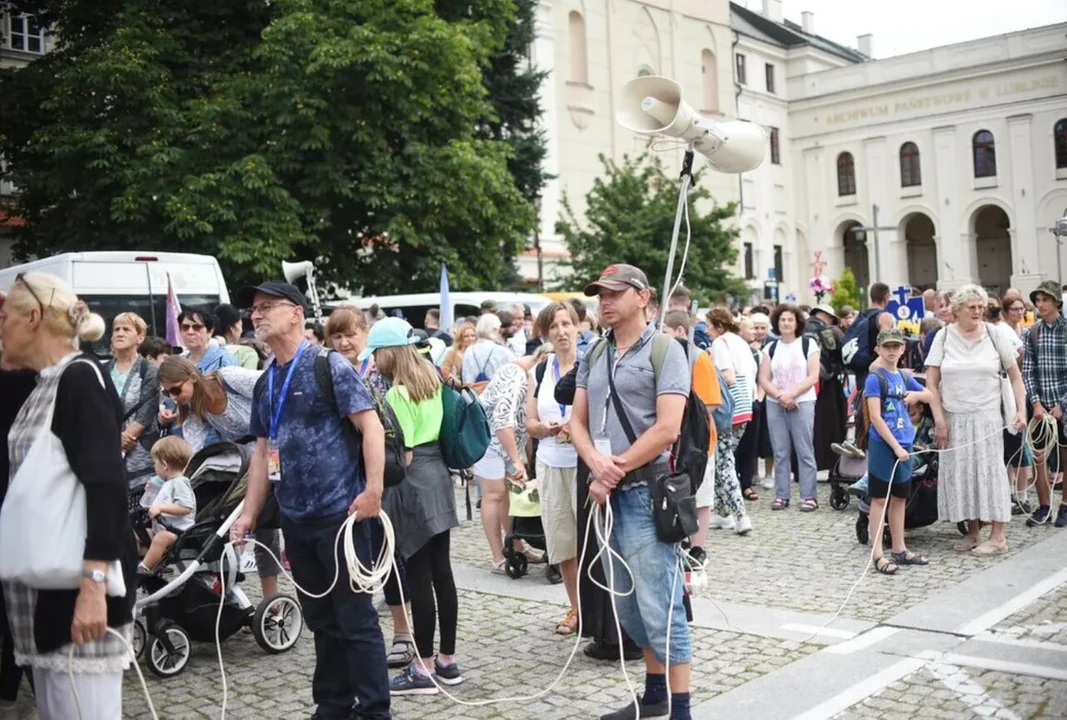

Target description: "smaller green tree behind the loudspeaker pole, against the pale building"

left=556, top=155, right=745, bottom=302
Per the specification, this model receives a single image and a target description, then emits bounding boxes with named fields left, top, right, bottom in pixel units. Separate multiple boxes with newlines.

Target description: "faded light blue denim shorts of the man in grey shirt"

left=602, top=485, right=692, bottom=665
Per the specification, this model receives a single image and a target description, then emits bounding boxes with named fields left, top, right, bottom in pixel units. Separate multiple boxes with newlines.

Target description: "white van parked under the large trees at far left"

left=0, top=251, right=229, bottom=337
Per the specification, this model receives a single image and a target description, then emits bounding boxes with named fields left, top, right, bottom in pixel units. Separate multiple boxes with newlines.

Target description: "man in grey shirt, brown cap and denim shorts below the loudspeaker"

left=571, top=265, right=691, bottom=720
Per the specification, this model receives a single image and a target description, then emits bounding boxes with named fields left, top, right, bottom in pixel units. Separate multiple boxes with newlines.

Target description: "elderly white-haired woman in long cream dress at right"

left=926, top=285, right=1026, bottom=555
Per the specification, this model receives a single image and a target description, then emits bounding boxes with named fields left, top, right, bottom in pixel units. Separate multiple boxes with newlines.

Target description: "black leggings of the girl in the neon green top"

left=404, top=530, right=460, bottom=657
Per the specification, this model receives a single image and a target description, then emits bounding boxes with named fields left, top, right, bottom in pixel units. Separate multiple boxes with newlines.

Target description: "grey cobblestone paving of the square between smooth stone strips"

left=2, top=483, right=1067, bottom=720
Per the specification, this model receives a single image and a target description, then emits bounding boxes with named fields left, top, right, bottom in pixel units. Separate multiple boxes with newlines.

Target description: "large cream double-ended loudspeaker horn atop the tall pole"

left=616, top=76, right=767, bottom=173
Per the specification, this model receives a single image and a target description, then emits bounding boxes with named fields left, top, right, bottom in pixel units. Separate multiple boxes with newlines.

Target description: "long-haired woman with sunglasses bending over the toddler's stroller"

left=159, top=355, right=282, bottom=597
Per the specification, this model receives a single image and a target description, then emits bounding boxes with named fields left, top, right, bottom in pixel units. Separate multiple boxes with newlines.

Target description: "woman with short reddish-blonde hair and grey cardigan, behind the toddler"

left=107, top=313, right=159, bottom=511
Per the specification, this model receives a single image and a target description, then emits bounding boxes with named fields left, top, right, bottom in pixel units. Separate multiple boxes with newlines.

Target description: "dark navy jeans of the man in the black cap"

left=282, top=515, right=392, bottom=720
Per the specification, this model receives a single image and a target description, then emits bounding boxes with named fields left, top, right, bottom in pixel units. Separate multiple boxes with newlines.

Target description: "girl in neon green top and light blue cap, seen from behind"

left=360, top=318, right=463, bottom=695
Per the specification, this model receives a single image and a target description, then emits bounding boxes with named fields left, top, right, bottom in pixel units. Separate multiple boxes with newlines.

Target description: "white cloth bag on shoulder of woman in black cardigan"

left=0, top=359, right=126, bottom=597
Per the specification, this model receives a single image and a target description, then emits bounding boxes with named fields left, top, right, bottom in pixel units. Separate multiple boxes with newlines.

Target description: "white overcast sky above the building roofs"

left=737, top=0, right=1067, bottom=58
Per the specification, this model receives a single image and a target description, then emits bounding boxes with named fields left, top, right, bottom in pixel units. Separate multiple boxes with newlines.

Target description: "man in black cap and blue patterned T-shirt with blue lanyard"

left=230, top=283, right=391, bottom=720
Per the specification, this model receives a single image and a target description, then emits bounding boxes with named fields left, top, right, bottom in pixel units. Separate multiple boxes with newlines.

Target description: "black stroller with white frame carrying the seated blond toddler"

left=133, top=443, right=303, bottom=677
